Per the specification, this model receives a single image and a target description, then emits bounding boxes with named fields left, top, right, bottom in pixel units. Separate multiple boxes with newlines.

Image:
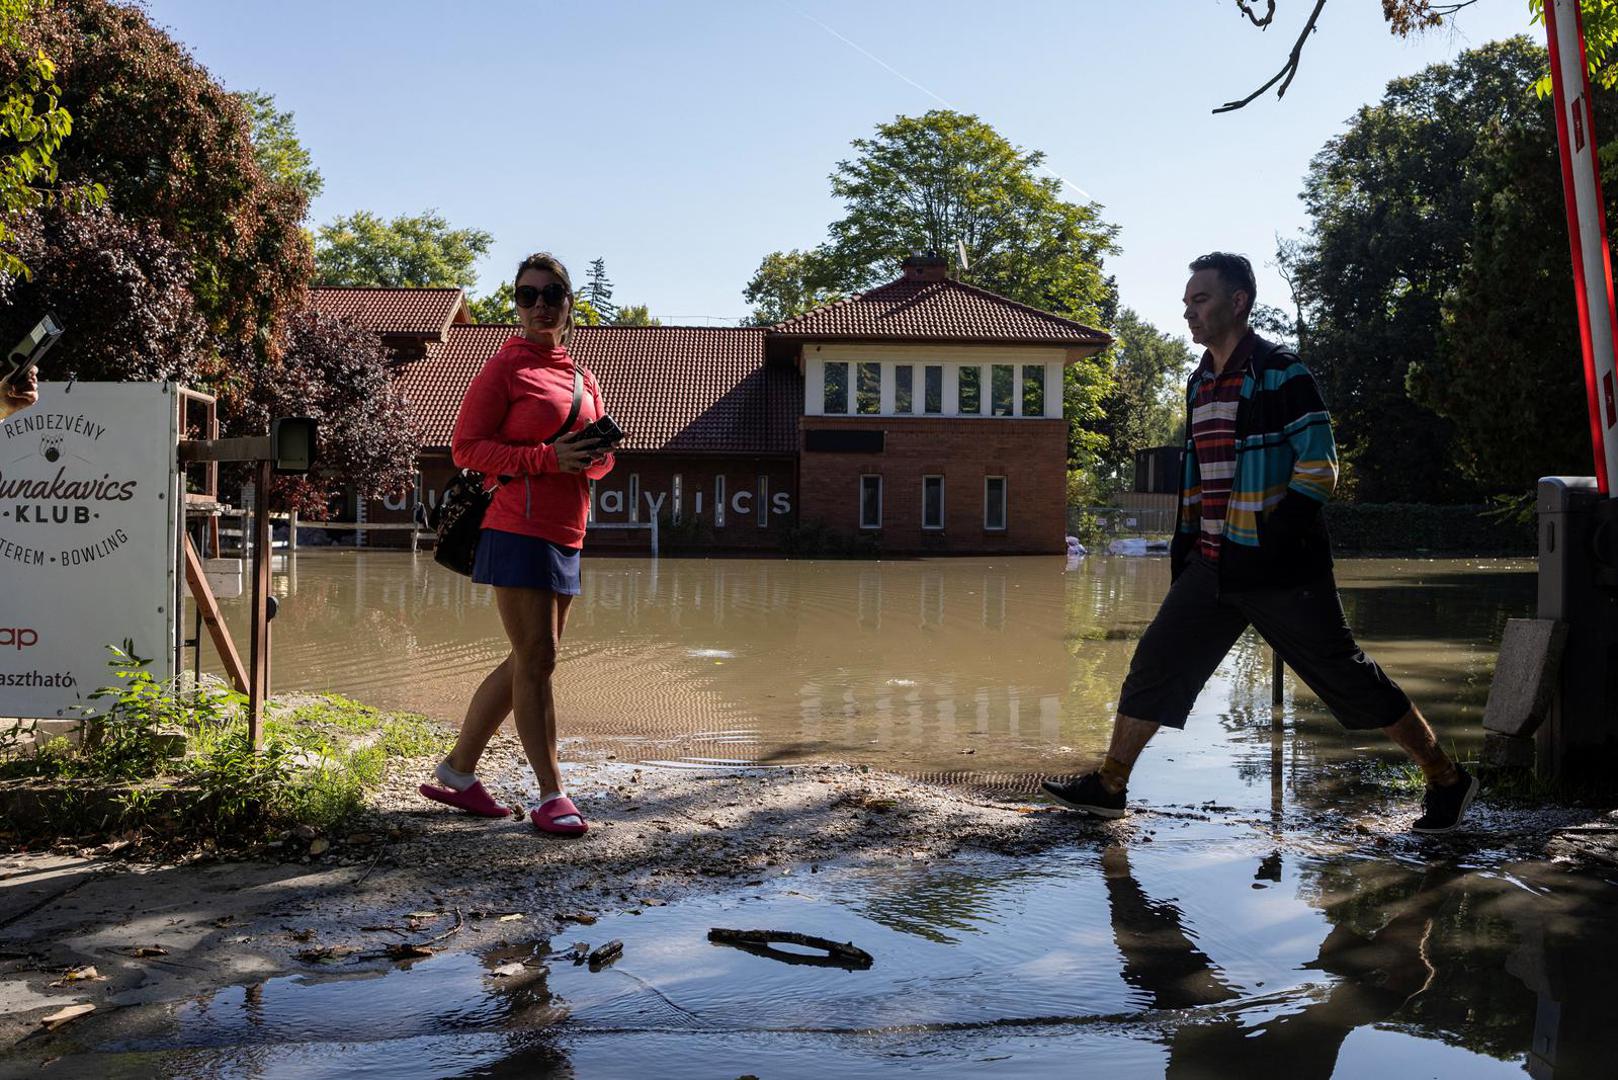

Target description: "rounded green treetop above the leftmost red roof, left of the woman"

left=314, top=210, right=493, bottom=290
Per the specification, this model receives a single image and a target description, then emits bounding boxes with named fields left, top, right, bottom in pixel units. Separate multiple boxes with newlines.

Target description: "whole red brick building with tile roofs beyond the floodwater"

left=314, top=257, right=1110, bottom=555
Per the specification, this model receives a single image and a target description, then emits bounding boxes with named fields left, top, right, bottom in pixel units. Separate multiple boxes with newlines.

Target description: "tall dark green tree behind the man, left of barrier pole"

left=1296, top=37, right=1571, bottom=502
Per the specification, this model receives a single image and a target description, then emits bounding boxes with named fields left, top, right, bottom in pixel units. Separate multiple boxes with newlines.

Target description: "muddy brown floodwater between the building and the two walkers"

left=195, top=551, right=1534, bottom=801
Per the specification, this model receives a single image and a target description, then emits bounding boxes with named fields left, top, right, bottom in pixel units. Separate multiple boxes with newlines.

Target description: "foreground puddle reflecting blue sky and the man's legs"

left=34, top=821, right=1618, bottom=1080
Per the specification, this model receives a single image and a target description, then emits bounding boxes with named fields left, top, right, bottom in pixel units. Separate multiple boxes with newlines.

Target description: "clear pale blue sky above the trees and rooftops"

left=149, top=0, right=1542, bottom=341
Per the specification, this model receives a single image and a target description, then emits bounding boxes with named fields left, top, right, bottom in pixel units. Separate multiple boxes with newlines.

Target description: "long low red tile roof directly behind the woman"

left=393, top=325, right=803, bottom=453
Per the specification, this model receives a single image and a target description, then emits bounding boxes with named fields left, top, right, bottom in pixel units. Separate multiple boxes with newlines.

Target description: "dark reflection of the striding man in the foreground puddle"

left=1102, top=845, right=1451, bottom=1080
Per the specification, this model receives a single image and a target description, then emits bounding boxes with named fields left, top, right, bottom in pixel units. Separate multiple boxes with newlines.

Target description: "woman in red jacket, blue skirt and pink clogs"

left=421, top=253, right=613, bottom=836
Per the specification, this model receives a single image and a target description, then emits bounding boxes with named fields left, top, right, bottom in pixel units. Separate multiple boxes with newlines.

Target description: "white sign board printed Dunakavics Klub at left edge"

left=0, top=382, right=180, bottom=717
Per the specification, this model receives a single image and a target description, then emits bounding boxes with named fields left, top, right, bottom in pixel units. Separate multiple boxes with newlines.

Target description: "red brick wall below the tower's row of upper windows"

left=799, top=416, right=1066, bottom=554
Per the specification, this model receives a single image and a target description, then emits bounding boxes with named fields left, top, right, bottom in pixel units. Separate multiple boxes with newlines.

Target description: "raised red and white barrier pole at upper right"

left=1545, top=0, right=1618, bottom=495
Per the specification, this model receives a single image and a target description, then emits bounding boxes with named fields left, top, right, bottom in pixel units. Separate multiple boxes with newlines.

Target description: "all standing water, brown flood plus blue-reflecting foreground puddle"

left=66, top=552, right=1618, bottom=1080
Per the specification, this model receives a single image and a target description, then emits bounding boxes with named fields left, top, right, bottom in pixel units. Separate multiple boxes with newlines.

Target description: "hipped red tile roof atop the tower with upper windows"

left=770, top=277, right=1112, bottom=348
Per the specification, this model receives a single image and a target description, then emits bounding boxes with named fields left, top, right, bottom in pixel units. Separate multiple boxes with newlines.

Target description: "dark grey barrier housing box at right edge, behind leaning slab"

left=1537, top=476, right=1618, bottom=787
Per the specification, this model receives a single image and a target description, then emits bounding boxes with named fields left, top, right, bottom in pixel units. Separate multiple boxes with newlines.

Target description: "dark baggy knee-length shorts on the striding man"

left=1118, top=555, right=1411, bottom=730
